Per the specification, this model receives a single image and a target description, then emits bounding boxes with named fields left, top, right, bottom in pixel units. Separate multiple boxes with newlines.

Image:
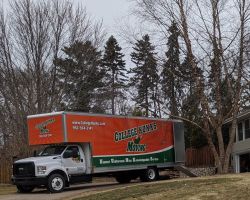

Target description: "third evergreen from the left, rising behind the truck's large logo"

left=130, top=35, right=159, bottom=116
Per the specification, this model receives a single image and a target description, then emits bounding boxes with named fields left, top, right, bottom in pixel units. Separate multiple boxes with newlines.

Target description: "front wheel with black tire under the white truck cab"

left=47, top=174, right=65, bottom=193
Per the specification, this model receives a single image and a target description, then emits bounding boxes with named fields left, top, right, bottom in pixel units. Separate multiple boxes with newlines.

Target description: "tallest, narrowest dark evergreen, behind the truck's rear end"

left=161, top=22, right=183, bottom=116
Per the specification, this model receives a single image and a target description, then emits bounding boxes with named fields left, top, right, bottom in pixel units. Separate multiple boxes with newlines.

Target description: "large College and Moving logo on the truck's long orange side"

left=114, top=122, right=157, bottom=152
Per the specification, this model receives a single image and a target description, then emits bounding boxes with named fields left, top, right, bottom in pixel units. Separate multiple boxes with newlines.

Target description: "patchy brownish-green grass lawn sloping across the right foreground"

left=74, top=174, right=250, bottom=200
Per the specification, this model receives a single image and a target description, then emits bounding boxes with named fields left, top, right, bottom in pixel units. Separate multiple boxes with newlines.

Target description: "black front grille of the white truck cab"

left=13, top=162, right=35, bottom=177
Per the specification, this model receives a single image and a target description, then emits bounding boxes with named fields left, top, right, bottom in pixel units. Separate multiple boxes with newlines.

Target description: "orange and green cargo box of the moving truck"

left=28, top=112, right=182, bottom=167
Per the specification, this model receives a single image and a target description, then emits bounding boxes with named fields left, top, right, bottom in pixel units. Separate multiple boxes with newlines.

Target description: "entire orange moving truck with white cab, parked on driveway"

left=12, top=112, right=185, bottom=192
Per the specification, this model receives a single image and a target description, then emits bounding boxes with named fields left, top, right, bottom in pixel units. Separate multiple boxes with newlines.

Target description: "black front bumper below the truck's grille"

left=11, top=177, right=48, bottom=186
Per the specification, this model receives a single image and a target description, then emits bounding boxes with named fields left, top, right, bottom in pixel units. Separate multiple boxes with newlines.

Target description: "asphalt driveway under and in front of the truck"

left=0, top=182, right=141, bottom=200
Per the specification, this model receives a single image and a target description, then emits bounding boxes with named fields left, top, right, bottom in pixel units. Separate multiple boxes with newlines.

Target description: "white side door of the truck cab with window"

left=62, top=145, right=86, bottom=175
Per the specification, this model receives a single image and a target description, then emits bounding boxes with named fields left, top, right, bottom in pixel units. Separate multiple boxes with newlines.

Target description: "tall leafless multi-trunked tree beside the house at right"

left=136, top=0, right=250, bottom=173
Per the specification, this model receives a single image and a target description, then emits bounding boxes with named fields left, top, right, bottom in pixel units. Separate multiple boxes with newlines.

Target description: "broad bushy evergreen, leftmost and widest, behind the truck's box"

left=54, top=41, right=103, bottom=112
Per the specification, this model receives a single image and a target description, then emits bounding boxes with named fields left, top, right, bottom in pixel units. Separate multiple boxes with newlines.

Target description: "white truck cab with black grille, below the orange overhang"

left=12, top=144, right=90, bottom=193
